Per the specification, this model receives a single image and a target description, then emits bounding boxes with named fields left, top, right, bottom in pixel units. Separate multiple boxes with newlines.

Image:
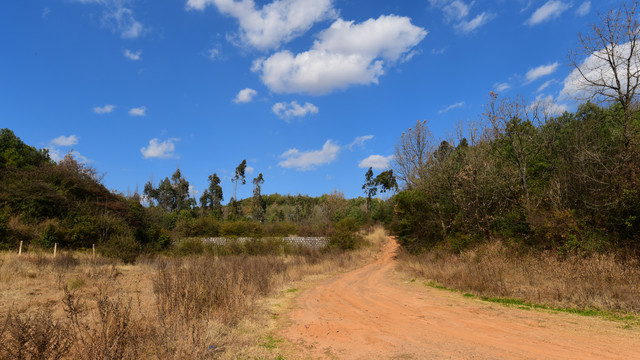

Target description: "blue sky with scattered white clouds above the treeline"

left=0, top=0, right=620, bottom=200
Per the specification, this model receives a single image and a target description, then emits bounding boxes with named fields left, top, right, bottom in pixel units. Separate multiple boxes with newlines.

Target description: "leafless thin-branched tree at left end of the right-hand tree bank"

left=394, top=120, right=434, bottom=188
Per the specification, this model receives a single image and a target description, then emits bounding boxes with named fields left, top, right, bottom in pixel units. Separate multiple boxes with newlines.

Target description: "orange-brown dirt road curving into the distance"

left=280, top=239, right=640, bottom=360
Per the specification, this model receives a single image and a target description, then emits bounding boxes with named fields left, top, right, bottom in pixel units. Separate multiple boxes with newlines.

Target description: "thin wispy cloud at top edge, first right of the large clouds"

left=429, top=0, right=495, bottom=34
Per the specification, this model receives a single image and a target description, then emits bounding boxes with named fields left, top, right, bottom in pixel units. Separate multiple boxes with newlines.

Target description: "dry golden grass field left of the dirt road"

left=0, top=229, right=384, bottom=359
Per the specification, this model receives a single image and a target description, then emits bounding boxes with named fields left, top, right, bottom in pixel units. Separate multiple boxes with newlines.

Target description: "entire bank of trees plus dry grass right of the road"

left=391, top=1, right=640, bottom=314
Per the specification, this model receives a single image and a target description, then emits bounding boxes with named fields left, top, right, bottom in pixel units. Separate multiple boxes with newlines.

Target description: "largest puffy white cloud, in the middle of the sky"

left=252, top=15, right=427, bottom=95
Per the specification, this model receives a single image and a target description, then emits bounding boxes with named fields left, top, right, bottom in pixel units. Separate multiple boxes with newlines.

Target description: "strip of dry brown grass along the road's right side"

left=400, top=242, right=640, bottom=314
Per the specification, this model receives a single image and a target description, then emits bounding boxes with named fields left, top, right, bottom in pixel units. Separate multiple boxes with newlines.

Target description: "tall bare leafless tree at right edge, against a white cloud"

left=564, top=0, right=640, bottom=147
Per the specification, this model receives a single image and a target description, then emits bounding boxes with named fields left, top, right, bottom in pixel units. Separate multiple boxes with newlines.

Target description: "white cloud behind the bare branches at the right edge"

left=560, top=43, right=640, bottom=99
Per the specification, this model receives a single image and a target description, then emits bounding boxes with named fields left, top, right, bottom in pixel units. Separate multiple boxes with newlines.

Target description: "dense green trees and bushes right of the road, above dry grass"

left=390, top=96, right=640, bottom=254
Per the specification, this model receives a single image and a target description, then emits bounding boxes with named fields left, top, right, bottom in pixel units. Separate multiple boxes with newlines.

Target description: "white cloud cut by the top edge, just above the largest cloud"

left=186, top=0, right=336, bottom=50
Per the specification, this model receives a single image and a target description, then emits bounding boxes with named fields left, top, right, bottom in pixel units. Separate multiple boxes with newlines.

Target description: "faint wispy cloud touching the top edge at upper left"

left=76, top=0, right=148, bottom=39
